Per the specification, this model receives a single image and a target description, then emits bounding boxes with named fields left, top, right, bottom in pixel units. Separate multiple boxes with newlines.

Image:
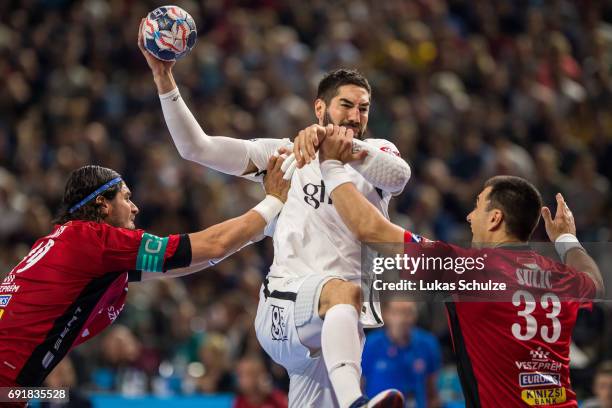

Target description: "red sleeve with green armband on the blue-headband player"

left=93, top=224, right=180, bottom=272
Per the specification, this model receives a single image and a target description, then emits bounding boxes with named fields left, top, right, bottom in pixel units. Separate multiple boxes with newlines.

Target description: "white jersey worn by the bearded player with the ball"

left=246, top=139, right=397, bottom=326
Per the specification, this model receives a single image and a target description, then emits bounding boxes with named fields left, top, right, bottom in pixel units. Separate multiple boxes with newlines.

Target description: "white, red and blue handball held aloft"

left=142, top=6, right=197, bottom=61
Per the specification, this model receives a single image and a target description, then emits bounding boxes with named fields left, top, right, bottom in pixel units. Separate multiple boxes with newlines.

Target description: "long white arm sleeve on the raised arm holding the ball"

left=156, top=87, right=252, bottom=175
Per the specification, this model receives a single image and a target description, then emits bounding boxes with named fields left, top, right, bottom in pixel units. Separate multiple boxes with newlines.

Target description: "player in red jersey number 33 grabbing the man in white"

left=319, top=127, right=604, bottom=407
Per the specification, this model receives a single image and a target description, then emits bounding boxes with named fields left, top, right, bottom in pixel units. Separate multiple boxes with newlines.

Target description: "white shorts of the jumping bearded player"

left=255, top=274, right=363, bottom=408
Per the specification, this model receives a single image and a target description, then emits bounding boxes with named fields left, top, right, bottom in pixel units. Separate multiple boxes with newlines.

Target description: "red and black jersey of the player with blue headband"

left=0, top=221, right=191, bottom=386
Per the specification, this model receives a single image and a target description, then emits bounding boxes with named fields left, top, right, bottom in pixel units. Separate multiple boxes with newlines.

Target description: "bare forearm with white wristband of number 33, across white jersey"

left=321, top=160, right=404, bottom=253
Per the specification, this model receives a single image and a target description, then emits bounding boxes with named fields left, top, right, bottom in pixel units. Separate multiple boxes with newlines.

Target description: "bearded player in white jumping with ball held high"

left=138, top=25, right=410, bottom=408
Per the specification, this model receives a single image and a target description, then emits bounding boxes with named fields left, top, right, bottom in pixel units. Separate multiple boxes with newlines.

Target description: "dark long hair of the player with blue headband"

left=53, top=165, right=123, bottom=224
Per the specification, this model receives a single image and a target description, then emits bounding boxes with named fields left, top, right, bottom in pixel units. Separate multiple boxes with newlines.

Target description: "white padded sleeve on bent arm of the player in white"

left=349, top=140, right=411, bottom=194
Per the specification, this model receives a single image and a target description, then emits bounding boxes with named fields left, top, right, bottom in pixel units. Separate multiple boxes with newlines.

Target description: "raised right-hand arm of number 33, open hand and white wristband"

left=542, top=194, right=605, bottom=297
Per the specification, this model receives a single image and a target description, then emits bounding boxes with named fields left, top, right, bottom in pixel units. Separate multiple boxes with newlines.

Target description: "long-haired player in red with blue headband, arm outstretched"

left=0, top=160, right=289, bottom=406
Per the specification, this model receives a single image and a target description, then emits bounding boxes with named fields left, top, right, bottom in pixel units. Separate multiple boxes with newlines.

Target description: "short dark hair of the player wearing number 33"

left=484, top=176, right=542, bottom=241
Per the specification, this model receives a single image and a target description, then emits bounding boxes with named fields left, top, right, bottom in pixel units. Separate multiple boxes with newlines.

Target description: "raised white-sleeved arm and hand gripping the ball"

left=138, top=19, right=288, bottom=176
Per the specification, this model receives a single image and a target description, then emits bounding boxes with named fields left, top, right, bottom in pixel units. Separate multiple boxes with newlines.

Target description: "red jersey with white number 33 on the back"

left=405, top=232, right=596, bottom=407
